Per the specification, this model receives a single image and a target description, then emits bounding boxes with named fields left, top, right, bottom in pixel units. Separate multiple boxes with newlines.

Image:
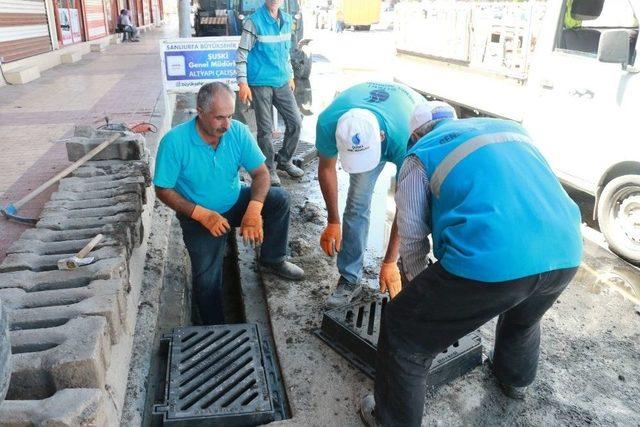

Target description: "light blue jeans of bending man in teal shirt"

left=337, top=162, right=385, bottom=283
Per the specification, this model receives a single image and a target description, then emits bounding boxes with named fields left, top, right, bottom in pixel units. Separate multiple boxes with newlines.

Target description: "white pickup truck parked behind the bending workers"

left=394, top=0, right=640, bottom=264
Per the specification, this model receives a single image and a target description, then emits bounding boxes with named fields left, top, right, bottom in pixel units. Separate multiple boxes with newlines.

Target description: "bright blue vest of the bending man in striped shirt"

left=407, top=118, right=582, bottom=282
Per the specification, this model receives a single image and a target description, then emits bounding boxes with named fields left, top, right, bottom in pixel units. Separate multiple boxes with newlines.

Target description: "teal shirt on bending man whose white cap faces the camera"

left=316, top=82, right=426, bottom=169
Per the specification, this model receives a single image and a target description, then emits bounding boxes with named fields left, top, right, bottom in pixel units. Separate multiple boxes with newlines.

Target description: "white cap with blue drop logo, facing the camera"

left=336, top=108, right=382, bottom=173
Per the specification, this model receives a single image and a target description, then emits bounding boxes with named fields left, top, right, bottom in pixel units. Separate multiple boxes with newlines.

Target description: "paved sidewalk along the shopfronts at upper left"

left=0, top=24, right=178, bottom=261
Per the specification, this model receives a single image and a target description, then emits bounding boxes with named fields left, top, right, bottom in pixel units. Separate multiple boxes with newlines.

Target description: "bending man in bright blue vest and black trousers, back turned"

left=360, top=102, right=582, bottom=426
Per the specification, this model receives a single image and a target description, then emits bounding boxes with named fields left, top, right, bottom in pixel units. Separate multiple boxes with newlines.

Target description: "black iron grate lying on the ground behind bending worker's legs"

left=315, top=295, right=482, bottom=386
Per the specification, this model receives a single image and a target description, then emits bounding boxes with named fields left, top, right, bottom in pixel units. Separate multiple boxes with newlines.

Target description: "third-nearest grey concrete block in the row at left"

left=0, top=279, right=129, bottom=343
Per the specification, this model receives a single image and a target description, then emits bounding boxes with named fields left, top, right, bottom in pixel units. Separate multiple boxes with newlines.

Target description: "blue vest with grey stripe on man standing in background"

left=247, top=4, right=293, bottom=87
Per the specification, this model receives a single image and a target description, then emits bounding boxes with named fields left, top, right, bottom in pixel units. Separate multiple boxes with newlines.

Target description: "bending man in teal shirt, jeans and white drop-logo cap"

left=316, top=82, right=425, bottom=307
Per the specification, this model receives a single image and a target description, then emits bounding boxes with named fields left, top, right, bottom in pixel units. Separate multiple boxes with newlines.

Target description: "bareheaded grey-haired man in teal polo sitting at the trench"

left=153, top=83, right=304, bottom=324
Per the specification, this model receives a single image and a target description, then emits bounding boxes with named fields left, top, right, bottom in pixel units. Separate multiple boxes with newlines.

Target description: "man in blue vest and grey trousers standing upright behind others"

left=236, top=0, right=304, bottom=186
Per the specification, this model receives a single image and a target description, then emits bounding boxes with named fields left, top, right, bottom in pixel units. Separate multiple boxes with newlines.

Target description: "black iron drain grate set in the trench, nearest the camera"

left=154, top=324, right=284, bottom=426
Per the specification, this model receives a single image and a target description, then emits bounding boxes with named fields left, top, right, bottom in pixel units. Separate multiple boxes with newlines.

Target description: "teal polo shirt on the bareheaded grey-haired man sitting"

left=153, top=118, right=265, bottom=213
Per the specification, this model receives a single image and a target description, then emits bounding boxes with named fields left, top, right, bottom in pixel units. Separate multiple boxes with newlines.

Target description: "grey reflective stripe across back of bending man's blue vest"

left=429, top=132, right=531, bottom=197
